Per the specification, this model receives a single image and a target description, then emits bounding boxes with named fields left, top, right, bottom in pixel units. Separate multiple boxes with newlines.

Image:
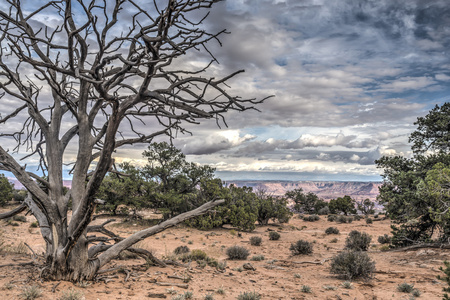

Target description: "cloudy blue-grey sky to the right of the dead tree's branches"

left=2, top=0, right=450, bottom=181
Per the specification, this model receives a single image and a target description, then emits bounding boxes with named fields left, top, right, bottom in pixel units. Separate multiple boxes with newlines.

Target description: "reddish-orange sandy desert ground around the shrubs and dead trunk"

left=0, top=209, right=450, bottom=300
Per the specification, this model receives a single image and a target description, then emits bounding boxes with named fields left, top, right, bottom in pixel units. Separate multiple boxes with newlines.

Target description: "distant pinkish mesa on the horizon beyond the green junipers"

left=226, top=180, right=382, bottom=201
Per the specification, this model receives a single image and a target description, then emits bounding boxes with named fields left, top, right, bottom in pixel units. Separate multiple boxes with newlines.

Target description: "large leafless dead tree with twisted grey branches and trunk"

left=0, top=0, right=264, bottom=281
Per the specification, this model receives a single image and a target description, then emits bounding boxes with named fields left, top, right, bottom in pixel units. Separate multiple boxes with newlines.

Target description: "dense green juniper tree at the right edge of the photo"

left=376, top=103, right=450, bottom=246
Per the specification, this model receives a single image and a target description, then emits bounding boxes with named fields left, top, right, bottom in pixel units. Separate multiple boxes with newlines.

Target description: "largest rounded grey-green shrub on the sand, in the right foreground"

left=330, top=251, right=375, bottom=280
